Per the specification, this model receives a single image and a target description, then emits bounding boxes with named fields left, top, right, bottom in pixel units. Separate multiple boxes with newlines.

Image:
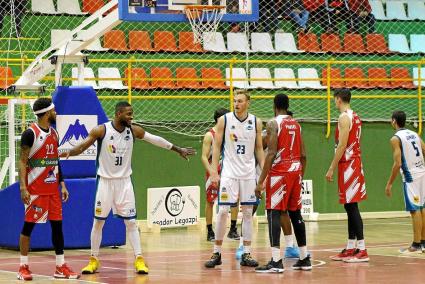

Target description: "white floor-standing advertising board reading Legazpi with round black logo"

left=148, top=186, right=200, bottom=228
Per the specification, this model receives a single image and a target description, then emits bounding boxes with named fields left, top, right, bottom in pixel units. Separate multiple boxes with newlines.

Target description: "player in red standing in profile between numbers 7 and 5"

left=326, top=89, right=369, bottom=262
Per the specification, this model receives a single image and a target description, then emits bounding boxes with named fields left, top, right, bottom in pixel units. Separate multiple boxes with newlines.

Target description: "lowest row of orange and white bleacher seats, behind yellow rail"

left=0, top=67, right=425, bottom=90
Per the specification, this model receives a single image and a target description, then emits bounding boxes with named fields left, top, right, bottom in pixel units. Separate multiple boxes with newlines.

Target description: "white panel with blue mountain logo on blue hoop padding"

left=56, top=115, right=97, bottom=160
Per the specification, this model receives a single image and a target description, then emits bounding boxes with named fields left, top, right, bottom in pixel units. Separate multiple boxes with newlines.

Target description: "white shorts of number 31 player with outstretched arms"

left=94, top=177, right=136, bottom=220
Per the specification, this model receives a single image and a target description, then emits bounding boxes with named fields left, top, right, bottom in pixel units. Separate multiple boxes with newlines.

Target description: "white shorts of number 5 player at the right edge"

left=403, top=175, right=425, bottom=211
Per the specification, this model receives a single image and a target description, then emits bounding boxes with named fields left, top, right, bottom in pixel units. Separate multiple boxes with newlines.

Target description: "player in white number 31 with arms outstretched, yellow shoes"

left=61, top=102, right=196, bottom=274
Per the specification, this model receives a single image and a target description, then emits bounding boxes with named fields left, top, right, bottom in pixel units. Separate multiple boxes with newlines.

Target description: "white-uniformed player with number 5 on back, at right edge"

left=385, top=111, right=425, bottom=253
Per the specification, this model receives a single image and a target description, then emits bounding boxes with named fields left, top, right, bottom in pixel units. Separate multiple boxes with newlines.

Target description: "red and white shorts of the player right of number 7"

left=338, top=158, right=366, bottom=204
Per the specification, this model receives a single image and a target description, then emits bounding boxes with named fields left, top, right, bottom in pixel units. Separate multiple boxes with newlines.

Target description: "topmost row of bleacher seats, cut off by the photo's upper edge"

left=31, top=0, right=425, bottom=21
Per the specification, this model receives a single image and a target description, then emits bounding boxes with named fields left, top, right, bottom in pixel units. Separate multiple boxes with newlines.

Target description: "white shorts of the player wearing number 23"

left=218, top=177, right=258, bottom=206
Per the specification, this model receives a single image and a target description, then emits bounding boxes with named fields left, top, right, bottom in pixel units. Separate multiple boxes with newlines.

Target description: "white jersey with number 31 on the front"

left=97, top=121, right=134, bottom=178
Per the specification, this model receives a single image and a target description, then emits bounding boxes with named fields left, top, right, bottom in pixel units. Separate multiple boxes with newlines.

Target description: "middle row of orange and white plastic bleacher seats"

left=51, top=30, right=425, bottom=54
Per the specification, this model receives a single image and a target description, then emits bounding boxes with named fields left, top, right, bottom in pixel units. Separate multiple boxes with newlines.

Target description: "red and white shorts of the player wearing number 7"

left=266, top=172, right=302, bottom=211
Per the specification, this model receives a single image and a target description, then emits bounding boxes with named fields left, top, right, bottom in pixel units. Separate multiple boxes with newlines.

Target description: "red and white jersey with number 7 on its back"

left=270, top=115, right=302, bottom=175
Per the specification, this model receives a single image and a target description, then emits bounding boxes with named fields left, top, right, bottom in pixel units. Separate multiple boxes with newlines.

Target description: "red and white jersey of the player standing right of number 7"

left=335, top=109, right=362, bottom=163
